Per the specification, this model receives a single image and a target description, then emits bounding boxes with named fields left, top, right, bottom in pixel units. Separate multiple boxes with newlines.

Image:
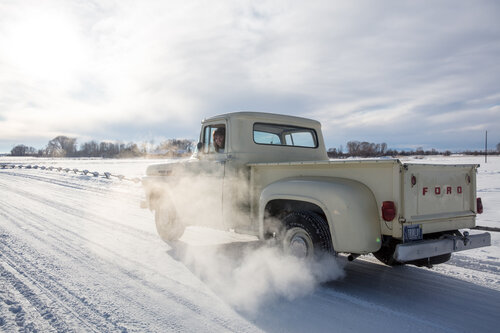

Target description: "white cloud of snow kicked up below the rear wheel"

left=176, top=239, right=344, bottom=315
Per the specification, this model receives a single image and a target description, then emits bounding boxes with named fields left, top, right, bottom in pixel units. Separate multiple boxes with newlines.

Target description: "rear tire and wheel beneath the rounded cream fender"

left=281, top=211, right=334, bottom=259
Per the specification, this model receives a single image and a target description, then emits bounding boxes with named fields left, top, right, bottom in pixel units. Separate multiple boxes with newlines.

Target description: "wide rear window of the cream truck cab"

left=253, top=123, right=318, bottom=148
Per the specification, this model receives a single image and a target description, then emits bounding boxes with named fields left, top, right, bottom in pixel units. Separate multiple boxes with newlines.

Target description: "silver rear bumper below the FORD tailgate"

left=394, top=232, right=491, bottom=262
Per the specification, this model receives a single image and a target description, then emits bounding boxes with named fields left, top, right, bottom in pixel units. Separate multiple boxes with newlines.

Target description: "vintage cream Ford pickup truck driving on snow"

left=142, top=112, right=491, bottom=267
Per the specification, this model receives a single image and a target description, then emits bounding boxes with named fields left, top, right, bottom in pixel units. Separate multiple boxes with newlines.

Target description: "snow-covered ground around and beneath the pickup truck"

left=0, top=157, right=500, bottom=332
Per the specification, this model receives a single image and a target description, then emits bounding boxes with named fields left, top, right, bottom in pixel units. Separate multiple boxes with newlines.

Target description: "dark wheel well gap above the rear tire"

left=264, top=199, right=327, bottom=238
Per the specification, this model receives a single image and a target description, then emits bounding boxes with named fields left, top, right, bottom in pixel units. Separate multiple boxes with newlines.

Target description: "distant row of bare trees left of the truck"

left=10, top=135, right=193, bottom=158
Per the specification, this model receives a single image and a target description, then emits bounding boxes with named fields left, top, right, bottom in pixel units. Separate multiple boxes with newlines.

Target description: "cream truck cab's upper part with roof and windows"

left=197, top=112, right=328, bottom=165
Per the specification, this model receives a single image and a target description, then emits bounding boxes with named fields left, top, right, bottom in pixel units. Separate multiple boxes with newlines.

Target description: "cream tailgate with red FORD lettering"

left=402, top=164, right=479, bottom=224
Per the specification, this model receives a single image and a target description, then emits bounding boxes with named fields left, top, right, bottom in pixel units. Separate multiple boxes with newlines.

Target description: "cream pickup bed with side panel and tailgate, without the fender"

left=248, top=159, right=478, bottom=238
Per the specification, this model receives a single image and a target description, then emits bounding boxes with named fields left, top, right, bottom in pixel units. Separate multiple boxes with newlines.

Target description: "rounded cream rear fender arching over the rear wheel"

left=259, top=177, right=381, bottom=253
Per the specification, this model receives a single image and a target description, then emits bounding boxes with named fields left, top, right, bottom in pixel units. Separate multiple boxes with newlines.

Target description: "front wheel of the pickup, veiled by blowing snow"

left=155, top=202, right=185, bottom=242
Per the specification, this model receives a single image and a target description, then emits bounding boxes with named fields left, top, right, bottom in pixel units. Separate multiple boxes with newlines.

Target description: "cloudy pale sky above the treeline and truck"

left=0, top=0, right=500, bottom=153
